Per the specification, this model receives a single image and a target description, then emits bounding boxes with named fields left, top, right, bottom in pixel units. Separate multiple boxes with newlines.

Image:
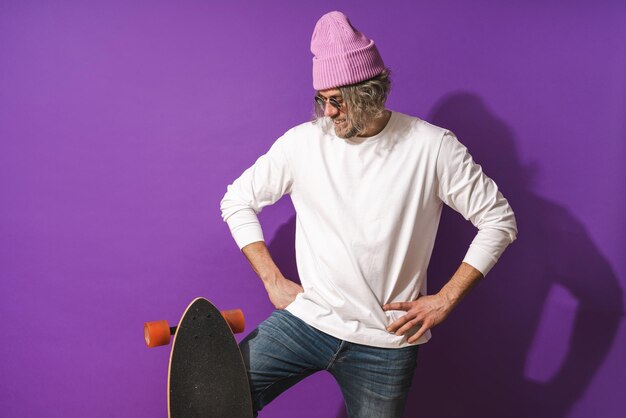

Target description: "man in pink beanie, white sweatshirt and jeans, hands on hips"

left=221, top=12, right=517, bottom=418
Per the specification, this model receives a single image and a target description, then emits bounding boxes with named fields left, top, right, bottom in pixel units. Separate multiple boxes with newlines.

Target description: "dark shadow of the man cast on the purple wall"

left=269, top=93, right=623, bottom=418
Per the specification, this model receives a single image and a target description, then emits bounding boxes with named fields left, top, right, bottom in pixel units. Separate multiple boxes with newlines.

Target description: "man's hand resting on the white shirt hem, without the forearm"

left=383, top=294, right=453, bottom=343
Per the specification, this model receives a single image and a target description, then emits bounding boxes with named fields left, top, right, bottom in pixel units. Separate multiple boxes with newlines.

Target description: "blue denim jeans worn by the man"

left=240, top=311, right=418, bottom=418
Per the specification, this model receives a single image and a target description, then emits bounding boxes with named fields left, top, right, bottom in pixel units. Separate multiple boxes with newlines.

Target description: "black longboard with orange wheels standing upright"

left=144, top=298, right=252, bottom=418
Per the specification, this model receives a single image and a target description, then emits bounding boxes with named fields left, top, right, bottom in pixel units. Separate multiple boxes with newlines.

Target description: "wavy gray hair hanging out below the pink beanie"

left=315, top=68, right=391, bottom=135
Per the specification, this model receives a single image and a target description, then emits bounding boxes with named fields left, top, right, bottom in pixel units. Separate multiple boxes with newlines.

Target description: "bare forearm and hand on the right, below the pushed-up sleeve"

left=383, top=263, right=483, bottom=343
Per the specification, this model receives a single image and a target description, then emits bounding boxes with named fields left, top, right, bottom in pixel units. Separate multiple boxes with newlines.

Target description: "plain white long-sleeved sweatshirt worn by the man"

left=221, top=112, right=517, bottom=348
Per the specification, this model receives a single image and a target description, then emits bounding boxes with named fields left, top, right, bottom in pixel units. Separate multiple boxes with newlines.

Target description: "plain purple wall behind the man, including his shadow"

left=0, top=0, right=626, bottom=418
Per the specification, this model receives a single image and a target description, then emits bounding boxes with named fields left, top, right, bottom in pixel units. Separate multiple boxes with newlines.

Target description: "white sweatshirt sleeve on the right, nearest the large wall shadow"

left=437, top=132, right=517, bottom=276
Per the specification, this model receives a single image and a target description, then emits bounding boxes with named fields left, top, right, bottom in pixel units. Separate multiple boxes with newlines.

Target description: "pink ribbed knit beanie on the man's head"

left=311, top=12, right=385, bottom=90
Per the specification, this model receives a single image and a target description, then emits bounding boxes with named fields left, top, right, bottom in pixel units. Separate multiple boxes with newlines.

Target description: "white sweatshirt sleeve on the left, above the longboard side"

left=220, top=136, right=293, bottom=249
